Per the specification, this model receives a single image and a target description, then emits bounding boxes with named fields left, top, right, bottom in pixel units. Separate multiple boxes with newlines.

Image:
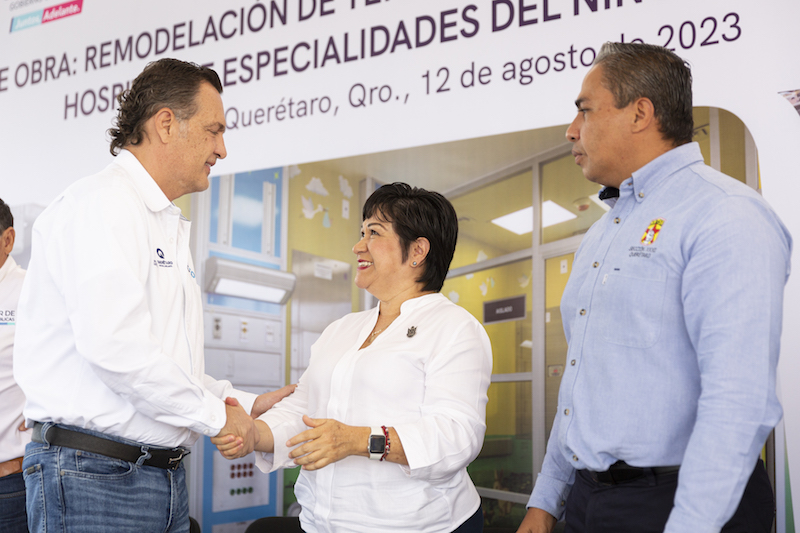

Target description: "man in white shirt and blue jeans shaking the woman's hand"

left=14, top=59, right=288, bottom=533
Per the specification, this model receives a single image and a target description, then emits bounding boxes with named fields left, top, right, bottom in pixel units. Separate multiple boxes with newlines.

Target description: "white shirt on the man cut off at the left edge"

left=0, top=256, right=31, bottom=463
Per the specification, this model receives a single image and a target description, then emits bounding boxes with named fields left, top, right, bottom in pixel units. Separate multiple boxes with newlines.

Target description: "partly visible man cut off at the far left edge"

left=0, top=199, right=31, bottom=533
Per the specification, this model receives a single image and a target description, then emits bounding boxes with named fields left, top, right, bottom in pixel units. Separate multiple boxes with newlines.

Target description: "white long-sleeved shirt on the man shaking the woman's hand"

left=14, top=150, right=255, bottom=447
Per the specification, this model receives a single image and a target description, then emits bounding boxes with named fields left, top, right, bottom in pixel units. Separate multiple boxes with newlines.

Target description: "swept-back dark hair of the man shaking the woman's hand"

left=108, top=58, right=222, bottom=156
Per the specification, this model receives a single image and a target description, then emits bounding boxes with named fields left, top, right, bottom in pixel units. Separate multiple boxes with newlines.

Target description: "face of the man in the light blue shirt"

left=567, top=65, right=633, bottom=187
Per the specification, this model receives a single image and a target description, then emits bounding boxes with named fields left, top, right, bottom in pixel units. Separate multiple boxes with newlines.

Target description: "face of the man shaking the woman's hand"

left=174, top=82, right=228, bottom=196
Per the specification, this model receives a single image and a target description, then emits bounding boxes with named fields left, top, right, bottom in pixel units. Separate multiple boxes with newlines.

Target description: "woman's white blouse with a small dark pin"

left=256, top=293, right=492, bottom=533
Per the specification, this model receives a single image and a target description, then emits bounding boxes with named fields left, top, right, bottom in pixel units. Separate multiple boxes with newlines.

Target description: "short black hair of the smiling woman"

left=362, top=183, right=458, bottom=292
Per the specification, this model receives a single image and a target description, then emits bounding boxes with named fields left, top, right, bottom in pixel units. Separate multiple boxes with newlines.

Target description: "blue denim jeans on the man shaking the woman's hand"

left=22, top=424, right=189, bottom=533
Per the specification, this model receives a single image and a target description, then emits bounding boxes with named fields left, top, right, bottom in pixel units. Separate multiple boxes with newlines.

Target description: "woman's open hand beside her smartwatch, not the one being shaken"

left=286, top=415, right=362, bottom=470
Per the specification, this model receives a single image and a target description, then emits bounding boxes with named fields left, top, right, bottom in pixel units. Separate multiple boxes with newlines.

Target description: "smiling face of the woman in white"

left=353, top=216, right=419, bottom=300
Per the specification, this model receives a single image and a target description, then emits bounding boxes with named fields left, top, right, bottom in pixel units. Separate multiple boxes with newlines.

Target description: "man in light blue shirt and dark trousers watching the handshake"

left=519, top=43, right=791, bottom=533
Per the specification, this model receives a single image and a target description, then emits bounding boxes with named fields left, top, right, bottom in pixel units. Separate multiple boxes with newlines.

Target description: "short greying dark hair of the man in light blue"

left=594, top=43, right=694, bottom=146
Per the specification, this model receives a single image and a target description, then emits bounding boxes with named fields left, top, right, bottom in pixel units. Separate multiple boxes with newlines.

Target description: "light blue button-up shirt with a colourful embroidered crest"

left=528, top=143, right=791, bottom=533
